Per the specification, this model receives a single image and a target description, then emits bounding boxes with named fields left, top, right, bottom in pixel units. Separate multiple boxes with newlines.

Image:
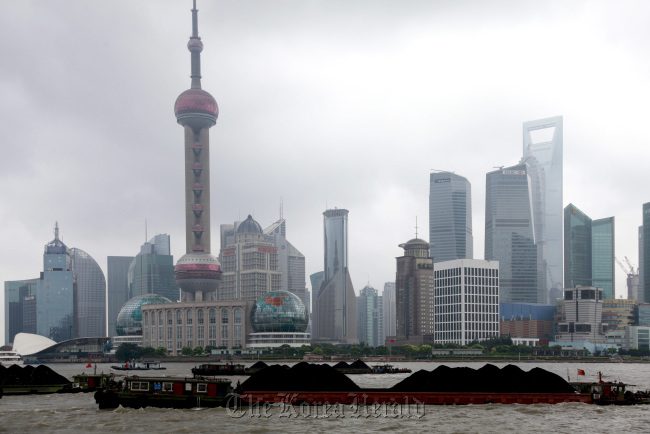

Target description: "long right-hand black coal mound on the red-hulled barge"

left=390, top=364, right=574, bottom=393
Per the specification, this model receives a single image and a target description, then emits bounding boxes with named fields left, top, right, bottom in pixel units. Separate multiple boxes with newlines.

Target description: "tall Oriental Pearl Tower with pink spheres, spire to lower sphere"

left=174, top=0, right=221, bottom=302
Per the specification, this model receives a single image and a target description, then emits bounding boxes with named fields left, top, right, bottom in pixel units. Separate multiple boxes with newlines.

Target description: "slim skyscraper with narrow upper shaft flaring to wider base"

left=312, top=209, right=359, bottom=344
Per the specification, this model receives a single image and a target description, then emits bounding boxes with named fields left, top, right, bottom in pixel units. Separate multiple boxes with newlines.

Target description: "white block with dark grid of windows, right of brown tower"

left=434, top=259, right=499, bottom=345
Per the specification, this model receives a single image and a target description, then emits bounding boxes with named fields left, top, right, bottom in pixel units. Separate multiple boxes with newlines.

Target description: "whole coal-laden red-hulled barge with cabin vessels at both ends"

left=95, top=362, right=650, bottom=410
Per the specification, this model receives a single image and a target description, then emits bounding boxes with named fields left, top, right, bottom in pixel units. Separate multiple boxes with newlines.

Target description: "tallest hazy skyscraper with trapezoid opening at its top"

left=522, top=116, right=564, bottom=303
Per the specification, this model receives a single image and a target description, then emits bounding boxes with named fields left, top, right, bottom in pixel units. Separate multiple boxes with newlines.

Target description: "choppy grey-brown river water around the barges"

left=0, top=362, right=650, bottom=434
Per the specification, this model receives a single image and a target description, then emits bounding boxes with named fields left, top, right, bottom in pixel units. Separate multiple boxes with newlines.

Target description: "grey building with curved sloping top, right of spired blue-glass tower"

left=70, top=247, right=106, bottom=338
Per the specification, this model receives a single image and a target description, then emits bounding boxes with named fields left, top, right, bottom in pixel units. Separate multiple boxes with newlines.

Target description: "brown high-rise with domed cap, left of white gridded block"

left=395, top=238, right=434, bottom=345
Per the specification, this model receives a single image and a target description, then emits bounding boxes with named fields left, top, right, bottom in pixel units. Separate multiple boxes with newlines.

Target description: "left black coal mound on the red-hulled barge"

left=241, top=362, right=359, bottom=392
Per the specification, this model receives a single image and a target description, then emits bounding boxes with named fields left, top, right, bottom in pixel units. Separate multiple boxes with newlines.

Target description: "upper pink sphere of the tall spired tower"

left=174, top=89, right=219, bottom=129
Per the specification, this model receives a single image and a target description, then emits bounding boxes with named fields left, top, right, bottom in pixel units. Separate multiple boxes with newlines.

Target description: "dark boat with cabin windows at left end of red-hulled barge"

left=95, top=376, right=232, bottom=410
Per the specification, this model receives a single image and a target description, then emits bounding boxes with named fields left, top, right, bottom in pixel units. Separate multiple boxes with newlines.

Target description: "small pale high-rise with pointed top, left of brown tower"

left=357, top=285, right=384, bottom=347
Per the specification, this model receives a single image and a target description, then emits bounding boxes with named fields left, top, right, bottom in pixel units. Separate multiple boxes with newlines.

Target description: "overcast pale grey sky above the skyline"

left=0, top=0, right=650, bottom=346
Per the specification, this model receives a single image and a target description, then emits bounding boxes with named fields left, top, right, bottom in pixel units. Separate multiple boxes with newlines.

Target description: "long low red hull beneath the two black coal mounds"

left=241, top=390, right=593, bottom=405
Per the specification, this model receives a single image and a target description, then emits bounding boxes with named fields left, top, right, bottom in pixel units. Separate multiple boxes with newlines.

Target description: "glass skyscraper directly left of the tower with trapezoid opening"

left=485, top=163, right=548, bottom=303
